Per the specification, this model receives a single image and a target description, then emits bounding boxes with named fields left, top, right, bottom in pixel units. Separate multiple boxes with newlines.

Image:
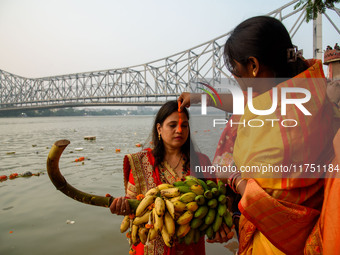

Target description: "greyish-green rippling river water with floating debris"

left=0, top=116, right=236, bottom=255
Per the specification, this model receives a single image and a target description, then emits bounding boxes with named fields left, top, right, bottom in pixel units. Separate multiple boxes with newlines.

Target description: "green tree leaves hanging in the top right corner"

left=294, top=0, right=340, bottom=22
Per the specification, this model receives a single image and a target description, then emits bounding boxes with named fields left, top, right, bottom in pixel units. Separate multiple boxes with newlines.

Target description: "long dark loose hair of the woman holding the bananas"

left=152, top=101, right=194, bottom=170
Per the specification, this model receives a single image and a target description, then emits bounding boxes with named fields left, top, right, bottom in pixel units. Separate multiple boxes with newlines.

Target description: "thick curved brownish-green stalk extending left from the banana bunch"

left=47, top=140, right=140, bottom=211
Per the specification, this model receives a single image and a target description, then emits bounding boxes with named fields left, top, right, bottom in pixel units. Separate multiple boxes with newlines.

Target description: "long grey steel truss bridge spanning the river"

left=0, top=0, right=340, bottom=112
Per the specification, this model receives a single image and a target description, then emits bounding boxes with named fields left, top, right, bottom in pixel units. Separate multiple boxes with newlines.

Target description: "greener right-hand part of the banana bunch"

left=170, top=176, right=233, bottom=244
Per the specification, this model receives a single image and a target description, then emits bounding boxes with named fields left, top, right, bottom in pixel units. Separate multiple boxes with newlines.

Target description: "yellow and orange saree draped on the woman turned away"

left=215, top=60, right=334, bottom=254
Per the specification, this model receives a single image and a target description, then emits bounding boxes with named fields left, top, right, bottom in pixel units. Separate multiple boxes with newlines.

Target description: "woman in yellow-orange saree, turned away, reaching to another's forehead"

left=179, top=16, right=335, bottom=254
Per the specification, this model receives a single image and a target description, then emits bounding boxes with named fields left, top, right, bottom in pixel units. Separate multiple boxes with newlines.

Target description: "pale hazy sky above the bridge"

left=0, top=0, right=340, bottom=78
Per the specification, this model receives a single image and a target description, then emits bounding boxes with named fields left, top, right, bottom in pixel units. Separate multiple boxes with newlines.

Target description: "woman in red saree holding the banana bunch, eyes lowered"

left=110, top=101, right=211, bottom=255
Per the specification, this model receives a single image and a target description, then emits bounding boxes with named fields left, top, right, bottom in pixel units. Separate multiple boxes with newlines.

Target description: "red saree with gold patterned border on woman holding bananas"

left=123, top=148, right=211, bottom=255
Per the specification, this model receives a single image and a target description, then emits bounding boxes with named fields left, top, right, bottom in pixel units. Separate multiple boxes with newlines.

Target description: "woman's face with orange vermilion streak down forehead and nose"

left=157, top=112, right=189, bottom=149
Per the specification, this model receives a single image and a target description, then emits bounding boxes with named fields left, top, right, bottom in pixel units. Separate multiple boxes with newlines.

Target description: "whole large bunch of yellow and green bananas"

left=121, top=176, right=232, bottom=247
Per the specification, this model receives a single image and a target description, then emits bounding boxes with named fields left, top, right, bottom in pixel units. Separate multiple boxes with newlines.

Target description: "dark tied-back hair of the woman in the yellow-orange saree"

left=224, top=16, right=307, bottom=78
